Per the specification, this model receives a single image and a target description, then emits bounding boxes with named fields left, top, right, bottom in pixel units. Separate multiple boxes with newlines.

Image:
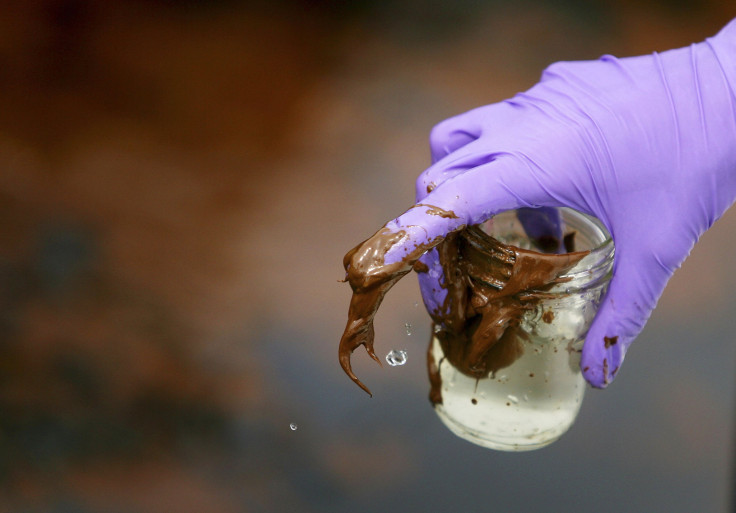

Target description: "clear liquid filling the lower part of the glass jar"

left=430, top=335, right=585, bottom=451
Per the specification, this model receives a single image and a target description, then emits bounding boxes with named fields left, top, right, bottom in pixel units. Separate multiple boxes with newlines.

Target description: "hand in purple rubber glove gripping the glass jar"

left=346, top=20, right=736, bottom=388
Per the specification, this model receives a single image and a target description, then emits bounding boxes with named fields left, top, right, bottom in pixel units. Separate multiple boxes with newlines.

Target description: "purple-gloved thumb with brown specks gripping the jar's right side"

left=580, top=247, right=671, bottom=388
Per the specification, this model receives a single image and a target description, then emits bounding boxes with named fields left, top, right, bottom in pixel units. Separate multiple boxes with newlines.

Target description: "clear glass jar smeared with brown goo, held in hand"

left=428, top=208, right=614, bottom=451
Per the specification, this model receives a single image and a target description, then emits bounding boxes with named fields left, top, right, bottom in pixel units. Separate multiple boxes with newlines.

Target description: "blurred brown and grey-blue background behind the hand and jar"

left=0, top=0, right=736, bottom=513
